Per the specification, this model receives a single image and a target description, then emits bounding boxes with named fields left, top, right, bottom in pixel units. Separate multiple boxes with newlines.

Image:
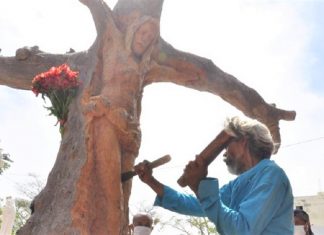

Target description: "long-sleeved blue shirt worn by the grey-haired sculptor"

left=154, top=159, right=294, bottom=235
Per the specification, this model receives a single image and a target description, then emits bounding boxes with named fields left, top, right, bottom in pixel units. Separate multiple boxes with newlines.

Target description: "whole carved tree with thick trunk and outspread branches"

left=0, top=0, right=295, bottom=235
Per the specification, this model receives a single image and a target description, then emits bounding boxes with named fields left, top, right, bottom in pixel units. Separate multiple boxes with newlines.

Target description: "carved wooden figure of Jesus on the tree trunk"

left=76, top=17, right=159, bottom=233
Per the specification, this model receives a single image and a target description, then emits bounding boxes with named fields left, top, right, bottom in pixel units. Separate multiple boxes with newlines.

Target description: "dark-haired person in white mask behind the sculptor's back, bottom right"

left=294, top=206, right=314, bottom=235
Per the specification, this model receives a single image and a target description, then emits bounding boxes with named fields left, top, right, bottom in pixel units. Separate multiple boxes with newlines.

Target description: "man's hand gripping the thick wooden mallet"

left=184, top=156, right=208, bottom=194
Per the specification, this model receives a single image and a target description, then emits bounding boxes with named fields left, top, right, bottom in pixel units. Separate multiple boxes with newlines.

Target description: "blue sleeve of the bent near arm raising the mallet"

left=198, top=172, right=286, bottom=235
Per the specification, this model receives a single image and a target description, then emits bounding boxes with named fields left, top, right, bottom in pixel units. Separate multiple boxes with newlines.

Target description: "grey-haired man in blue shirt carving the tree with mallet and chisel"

left=135, top=117, right=294, bottom=235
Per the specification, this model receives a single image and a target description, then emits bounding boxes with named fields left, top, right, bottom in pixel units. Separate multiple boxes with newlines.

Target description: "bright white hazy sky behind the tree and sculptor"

left=0, top=0, right=324, bottom=231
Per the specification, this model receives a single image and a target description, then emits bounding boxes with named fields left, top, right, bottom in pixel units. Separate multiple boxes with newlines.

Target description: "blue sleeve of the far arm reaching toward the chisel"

left=154, top=186, right=206, bottom=217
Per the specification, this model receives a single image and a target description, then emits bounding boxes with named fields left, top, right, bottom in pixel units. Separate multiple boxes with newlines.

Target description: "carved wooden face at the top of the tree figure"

left=132, top=21, right=158, bottom=56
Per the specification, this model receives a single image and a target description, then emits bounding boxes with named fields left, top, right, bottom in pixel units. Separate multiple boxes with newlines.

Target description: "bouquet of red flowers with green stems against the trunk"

left=32, top=64, right=80, bottom=135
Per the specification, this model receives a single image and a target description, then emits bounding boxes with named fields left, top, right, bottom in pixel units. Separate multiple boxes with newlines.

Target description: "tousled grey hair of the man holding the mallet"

left=224, top=116, right=274, bottom=160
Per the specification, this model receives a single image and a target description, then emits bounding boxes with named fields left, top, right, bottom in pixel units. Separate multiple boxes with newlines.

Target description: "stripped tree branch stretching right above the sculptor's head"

left=145, top=39, right=296, bottom=151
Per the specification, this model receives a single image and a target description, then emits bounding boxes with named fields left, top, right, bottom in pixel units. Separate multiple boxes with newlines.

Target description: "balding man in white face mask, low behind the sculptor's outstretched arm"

left=129, top=212, right=153, bottom=235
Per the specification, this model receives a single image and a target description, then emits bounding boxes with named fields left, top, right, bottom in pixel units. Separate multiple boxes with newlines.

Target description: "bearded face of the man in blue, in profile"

left=224, top=138, right=246, bottom=175
